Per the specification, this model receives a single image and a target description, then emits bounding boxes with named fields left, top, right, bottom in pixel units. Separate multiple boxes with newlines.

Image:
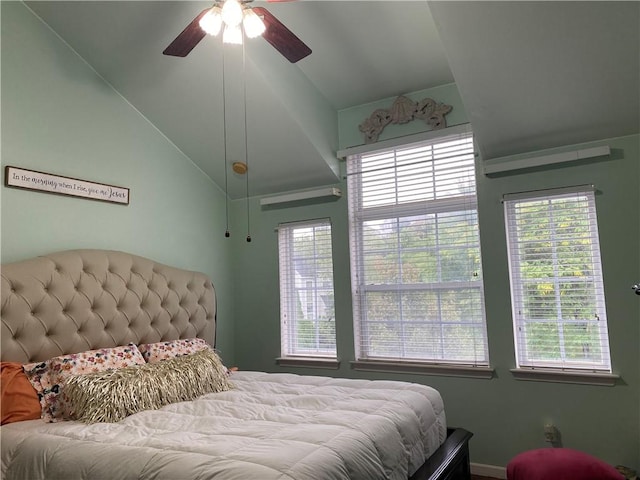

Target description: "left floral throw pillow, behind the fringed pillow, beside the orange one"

left=43, top=344, right=145, bottom=422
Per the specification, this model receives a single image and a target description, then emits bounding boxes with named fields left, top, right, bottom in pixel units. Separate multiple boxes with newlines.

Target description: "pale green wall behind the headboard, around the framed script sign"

left=0, top=2, right=234, bottom=358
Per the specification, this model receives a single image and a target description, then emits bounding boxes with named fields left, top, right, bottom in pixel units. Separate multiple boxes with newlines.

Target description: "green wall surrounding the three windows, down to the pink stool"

left=232, top=132, right=640, bottom=468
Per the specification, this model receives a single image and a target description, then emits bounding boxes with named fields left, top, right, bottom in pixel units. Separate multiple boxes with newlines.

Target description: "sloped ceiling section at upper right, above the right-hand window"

left=431, top=1, right=640, bottom=159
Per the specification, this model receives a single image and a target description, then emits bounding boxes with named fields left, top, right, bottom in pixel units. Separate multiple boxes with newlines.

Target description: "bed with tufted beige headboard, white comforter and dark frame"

left=0, top=250, right=471, bottom=480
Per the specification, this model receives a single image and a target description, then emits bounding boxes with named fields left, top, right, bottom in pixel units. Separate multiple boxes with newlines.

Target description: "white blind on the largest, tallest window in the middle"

left=347, top=129, right=489, bottom=366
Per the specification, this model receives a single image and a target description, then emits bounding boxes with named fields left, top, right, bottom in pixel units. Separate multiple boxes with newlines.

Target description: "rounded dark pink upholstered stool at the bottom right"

left=507, top=448, right=624, bottom=480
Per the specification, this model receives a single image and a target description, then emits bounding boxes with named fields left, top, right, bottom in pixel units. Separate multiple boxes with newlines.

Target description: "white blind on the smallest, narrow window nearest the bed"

left=278, top=220, right=336, bottom=358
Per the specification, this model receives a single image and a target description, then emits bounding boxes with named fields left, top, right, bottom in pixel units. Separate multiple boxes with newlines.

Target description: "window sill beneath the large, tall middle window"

left=351, top=360, right=494, bottom=380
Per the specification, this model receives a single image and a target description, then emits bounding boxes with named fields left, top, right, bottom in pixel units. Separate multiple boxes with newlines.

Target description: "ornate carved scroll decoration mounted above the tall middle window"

left=358, top=95, right=453, bottom=143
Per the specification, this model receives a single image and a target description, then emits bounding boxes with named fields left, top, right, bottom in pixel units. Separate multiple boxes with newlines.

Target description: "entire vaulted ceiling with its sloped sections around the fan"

left=26, top=0, right=640, bottom=198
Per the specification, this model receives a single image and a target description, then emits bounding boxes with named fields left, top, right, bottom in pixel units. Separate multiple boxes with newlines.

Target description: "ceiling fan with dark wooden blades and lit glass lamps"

left=162, top=0, right=311, bottom=63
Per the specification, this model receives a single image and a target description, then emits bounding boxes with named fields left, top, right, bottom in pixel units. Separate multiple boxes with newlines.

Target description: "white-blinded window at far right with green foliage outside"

left=504, top=186, right=611, bottom=372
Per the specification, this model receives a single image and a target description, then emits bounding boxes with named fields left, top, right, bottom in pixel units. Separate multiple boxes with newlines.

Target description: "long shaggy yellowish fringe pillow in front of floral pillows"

left=63, top=349, right=233, bottom=423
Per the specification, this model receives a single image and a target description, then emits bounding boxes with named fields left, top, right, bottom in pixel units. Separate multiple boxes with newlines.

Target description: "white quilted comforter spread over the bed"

left=1, top=372, right=446, bottom=480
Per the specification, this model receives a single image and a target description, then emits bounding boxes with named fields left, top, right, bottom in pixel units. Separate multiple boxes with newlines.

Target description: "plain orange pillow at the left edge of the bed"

left=0, top=362, right=42, bottom=425
